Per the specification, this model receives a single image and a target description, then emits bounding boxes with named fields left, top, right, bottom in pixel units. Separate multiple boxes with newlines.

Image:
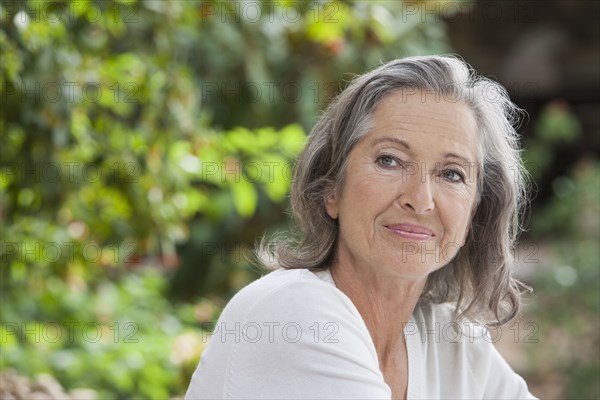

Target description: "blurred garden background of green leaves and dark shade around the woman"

left=0, top=0, right=600, bottom=399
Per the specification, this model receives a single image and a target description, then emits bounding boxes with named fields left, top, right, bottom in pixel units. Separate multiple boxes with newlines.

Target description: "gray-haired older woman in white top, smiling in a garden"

left=186, top=56, right=534, bottom=399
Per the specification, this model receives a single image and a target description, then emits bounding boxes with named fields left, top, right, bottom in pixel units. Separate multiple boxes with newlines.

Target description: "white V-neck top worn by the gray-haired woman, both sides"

left=186, top=269, right=535, bottom=400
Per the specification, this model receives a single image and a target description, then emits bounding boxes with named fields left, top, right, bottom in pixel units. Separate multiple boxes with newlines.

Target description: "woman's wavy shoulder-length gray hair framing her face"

left=256, top=56, right=528, bottom=326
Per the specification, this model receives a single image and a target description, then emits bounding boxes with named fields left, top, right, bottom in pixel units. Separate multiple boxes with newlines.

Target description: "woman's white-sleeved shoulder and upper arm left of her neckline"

left=186, top=269, right=390, bottom=398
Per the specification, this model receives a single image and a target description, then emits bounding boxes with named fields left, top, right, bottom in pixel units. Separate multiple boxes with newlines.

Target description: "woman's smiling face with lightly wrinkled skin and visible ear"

left=326, top=91, right=479, bottom=279
